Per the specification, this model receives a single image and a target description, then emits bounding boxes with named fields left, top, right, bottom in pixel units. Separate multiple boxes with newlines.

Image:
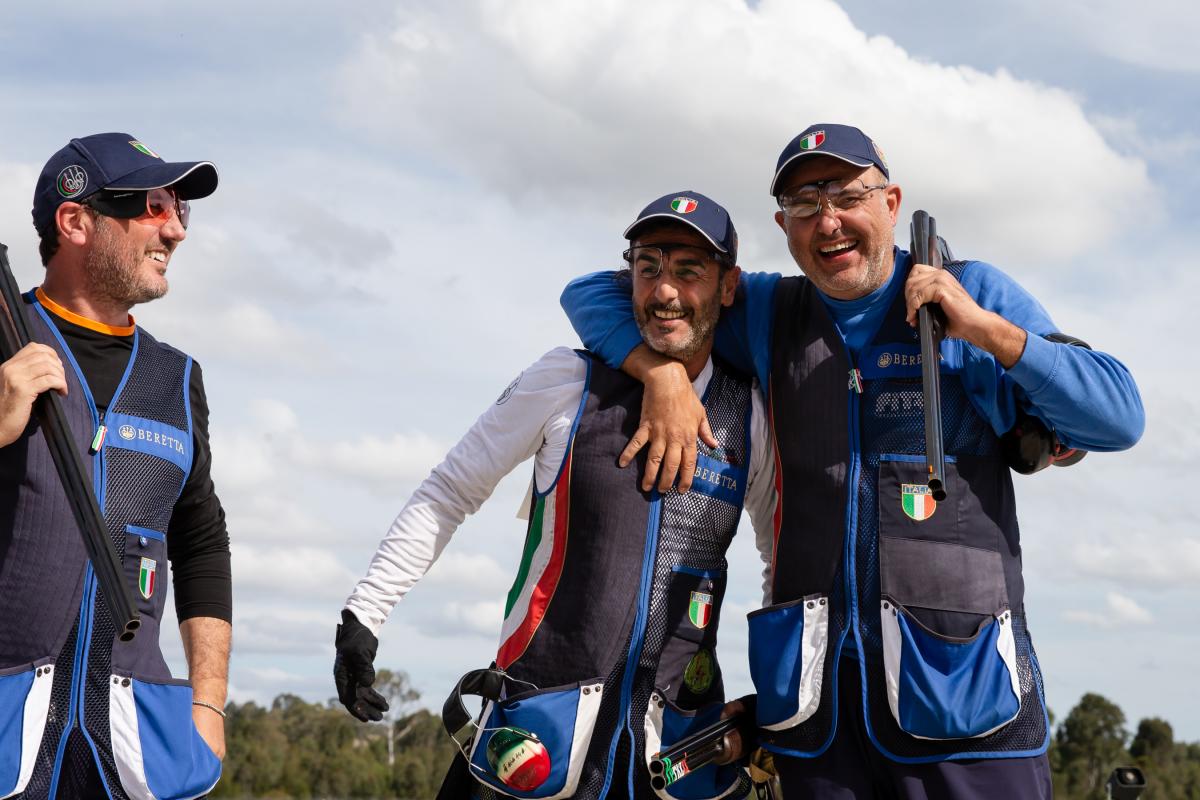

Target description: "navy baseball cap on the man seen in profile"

left=34, top=133, right=217, bottom=233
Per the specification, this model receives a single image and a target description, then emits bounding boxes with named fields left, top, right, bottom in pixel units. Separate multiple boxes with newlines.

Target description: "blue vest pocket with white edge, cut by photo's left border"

left=0, top=658, right=54, bottom=798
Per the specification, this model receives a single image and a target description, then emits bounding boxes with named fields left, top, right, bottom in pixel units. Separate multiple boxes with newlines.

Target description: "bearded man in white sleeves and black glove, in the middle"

left=334, top=191, right=774, bottom=799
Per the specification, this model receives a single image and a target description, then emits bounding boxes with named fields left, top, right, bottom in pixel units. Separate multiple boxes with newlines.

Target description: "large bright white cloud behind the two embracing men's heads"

left=344, top=0, right=1156, bottom=263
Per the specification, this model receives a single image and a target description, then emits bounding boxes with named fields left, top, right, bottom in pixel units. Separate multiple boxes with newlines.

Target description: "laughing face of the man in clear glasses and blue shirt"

left=775, top=156, right=900, bottom=300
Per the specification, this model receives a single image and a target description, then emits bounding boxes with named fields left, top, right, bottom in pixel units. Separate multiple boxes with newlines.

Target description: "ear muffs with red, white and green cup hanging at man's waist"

left=442, top=669, right=551, bottom=792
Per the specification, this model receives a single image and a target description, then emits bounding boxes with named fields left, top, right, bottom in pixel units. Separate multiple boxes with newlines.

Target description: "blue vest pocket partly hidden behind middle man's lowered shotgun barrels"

left=646, top=688, right=749, bottom=800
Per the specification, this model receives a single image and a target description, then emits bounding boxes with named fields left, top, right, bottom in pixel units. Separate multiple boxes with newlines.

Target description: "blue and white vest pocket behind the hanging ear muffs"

left=469, top=678, right=604, bottom=800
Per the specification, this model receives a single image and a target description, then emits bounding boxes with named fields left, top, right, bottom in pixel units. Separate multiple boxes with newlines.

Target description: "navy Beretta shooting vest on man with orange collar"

left=0, top=293, right=221, bottom=800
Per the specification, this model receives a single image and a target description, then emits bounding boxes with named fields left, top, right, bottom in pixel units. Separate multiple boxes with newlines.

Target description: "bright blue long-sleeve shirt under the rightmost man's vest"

left=562, top=248, right=1145, bottom=451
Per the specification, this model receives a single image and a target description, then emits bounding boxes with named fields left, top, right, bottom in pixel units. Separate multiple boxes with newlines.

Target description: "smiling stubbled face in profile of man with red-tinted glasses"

left=84, top=201, right=187, bottom=308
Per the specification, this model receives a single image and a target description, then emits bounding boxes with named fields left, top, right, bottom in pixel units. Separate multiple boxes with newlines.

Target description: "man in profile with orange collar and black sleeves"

left=0, top=133, right=232, bottom=800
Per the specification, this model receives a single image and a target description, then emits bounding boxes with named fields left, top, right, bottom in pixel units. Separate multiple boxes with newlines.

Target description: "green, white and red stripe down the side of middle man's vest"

left=496, top=453, right=571, bottom=669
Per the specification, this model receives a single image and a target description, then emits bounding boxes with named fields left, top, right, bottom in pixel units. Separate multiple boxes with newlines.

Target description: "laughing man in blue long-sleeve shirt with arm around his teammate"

left=563, top=124, right=1144, bottom=800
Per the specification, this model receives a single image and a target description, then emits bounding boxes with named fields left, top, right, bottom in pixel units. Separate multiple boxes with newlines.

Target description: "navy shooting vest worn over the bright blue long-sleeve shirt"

left=750, top=261, right=1049, bottom=763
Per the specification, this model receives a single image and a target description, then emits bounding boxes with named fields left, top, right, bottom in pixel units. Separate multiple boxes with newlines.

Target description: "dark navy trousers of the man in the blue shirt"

left=775, top=660, right=1052, bottom=800
